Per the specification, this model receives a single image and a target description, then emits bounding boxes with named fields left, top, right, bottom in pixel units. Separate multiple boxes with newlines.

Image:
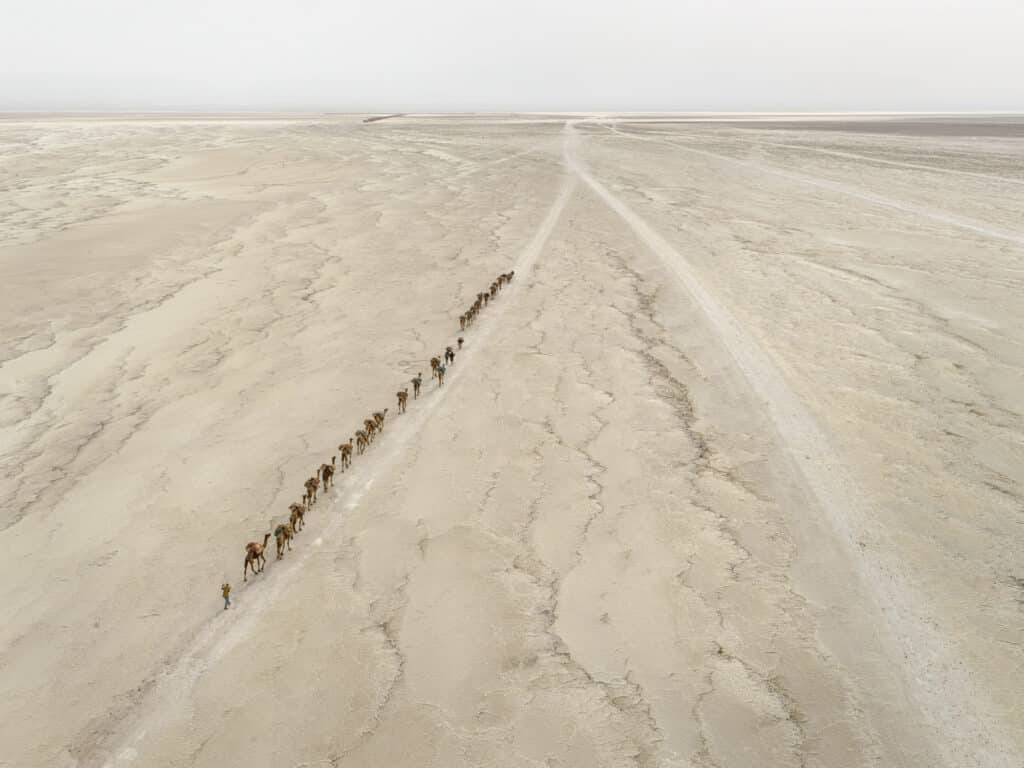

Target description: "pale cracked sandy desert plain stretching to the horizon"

left=0, top=116, right=1024, bottom=768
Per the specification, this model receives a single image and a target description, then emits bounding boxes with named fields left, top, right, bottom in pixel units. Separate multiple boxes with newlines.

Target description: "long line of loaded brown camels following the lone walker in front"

left=236, top=270, right=515, bottom=582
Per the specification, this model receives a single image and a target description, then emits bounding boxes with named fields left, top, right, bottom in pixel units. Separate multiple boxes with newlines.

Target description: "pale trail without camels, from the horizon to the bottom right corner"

left=565, top=123, right=1021, bottom=768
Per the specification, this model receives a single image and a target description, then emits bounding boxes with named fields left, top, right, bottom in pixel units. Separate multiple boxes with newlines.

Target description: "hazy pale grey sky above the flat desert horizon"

left=0, top=0, right=1024, bottom=111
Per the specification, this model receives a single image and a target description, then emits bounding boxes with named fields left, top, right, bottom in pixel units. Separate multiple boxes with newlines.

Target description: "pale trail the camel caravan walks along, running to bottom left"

left=88, top=169, right=575, bottom=768
